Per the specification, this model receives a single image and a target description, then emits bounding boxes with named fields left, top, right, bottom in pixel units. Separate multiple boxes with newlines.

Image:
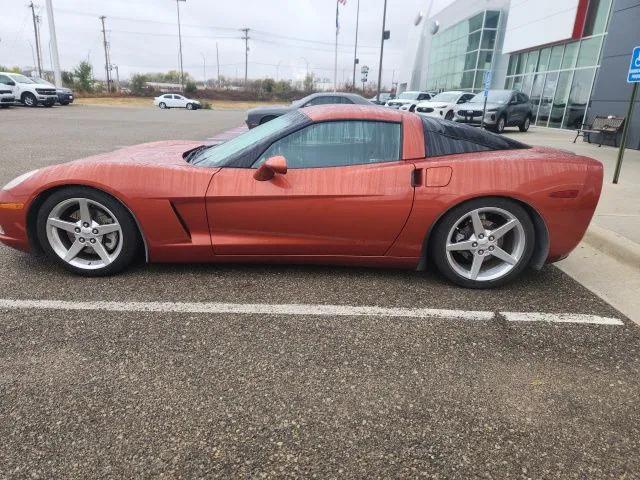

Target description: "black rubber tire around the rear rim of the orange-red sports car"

left=428, top=197, right=535, bottom=288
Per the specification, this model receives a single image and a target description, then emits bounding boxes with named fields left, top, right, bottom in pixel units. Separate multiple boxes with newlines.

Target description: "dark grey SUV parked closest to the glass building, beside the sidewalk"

left=454, top=90, right=533, bottom=133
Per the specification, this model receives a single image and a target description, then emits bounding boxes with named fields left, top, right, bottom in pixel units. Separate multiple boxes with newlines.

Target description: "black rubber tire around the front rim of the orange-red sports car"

left=36, top=187, right=140, bottom=277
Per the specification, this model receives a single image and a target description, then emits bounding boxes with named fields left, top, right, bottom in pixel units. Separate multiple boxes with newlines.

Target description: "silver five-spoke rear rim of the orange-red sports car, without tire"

left=446, top=207, right=526, bottom=282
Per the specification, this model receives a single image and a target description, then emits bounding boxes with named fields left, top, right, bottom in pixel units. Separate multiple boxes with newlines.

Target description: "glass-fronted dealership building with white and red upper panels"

left=398, top=0, right=640, bottom=149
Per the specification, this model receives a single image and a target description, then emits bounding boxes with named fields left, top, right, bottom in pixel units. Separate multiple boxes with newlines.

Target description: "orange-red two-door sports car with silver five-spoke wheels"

left=0, top=105, right=602, bottom=288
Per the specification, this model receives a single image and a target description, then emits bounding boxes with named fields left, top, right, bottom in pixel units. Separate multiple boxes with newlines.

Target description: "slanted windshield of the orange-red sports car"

left=191, top=112, right=299, bottom=167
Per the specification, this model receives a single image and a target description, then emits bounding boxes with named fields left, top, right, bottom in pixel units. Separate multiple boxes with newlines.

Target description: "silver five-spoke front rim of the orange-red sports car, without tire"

left=46, top=198, right=123, bottom=270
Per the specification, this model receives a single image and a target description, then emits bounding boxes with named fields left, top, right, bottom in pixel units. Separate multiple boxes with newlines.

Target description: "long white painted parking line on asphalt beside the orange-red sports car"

left=0, top=298, right=624, bottom=325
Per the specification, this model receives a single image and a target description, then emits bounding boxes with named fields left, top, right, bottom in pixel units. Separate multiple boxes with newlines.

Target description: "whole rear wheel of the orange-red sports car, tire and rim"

left=431, top=198, right=535, bottom=288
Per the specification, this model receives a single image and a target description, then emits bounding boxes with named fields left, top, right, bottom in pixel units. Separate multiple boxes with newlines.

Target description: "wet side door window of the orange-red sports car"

left=253, top=121, right=401, bottom=168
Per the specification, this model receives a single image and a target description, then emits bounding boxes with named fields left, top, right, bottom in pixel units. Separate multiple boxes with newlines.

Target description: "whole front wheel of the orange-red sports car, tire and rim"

left=37, top=187, right=139, bottom=277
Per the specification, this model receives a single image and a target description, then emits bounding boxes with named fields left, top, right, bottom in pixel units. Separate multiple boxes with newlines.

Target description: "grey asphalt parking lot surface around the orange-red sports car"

left=0, top=106, right=640, bottom=479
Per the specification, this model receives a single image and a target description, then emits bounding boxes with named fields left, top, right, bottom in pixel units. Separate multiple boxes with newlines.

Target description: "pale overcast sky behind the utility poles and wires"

left=0, top=0, right=450, bottom=85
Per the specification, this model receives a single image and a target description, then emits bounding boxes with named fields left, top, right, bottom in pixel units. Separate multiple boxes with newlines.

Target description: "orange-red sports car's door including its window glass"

left=206, top=121, right=414, bottom=256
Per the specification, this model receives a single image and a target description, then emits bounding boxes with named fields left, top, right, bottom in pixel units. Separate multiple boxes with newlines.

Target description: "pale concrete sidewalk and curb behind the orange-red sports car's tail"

left=507, top=127, right=640, bottom=324
